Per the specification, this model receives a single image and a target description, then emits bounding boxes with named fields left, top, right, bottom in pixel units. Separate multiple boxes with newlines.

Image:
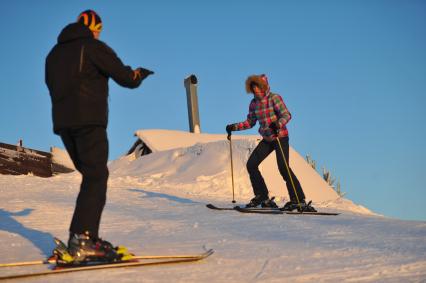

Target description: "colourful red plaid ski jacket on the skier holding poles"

left=232, top=93, right=291, bottom=141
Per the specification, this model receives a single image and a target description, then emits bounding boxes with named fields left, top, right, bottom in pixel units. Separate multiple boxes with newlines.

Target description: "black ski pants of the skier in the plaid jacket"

left=247, top=137, right=305, bottom=202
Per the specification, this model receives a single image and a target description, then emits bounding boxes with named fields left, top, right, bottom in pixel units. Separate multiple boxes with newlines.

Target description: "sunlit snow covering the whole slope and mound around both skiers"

left=0, top=131, right=426, bottom=282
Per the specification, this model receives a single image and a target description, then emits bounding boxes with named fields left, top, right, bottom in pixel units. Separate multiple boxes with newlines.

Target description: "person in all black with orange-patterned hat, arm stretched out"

left=45, top=10, right=153, bottom=262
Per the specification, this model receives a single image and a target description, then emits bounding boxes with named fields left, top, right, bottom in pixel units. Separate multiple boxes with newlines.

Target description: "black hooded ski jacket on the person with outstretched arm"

left=45, top=23, right=142, bottom=134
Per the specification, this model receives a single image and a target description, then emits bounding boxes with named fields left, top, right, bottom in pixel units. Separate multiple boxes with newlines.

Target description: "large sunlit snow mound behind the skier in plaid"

left=109, top=130, right=372, bottom=214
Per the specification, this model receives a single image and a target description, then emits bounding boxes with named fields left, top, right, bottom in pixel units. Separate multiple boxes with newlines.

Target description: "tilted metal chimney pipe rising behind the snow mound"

left=184, top=74, right=201, bottom=134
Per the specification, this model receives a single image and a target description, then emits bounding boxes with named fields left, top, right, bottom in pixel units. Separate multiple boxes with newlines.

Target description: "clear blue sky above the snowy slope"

left=0, top=0, right=426, bottom=220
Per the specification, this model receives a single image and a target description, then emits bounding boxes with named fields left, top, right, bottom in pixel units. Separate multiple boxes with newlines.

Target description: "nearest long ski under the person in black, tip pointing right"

left=0, top=249, right=214, bottom=280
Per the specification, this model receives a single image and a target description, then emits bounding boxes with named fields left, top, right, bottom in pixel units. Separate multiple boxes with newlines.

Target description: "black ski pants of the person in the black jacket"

left=59, top=126, right=109, bottom=237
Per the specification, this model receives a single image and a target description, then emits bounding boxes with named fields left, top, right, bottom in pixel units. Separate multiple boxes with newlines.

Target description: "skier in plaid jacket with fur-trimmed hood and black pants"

left=226, top=75, right=314, bottom=211
